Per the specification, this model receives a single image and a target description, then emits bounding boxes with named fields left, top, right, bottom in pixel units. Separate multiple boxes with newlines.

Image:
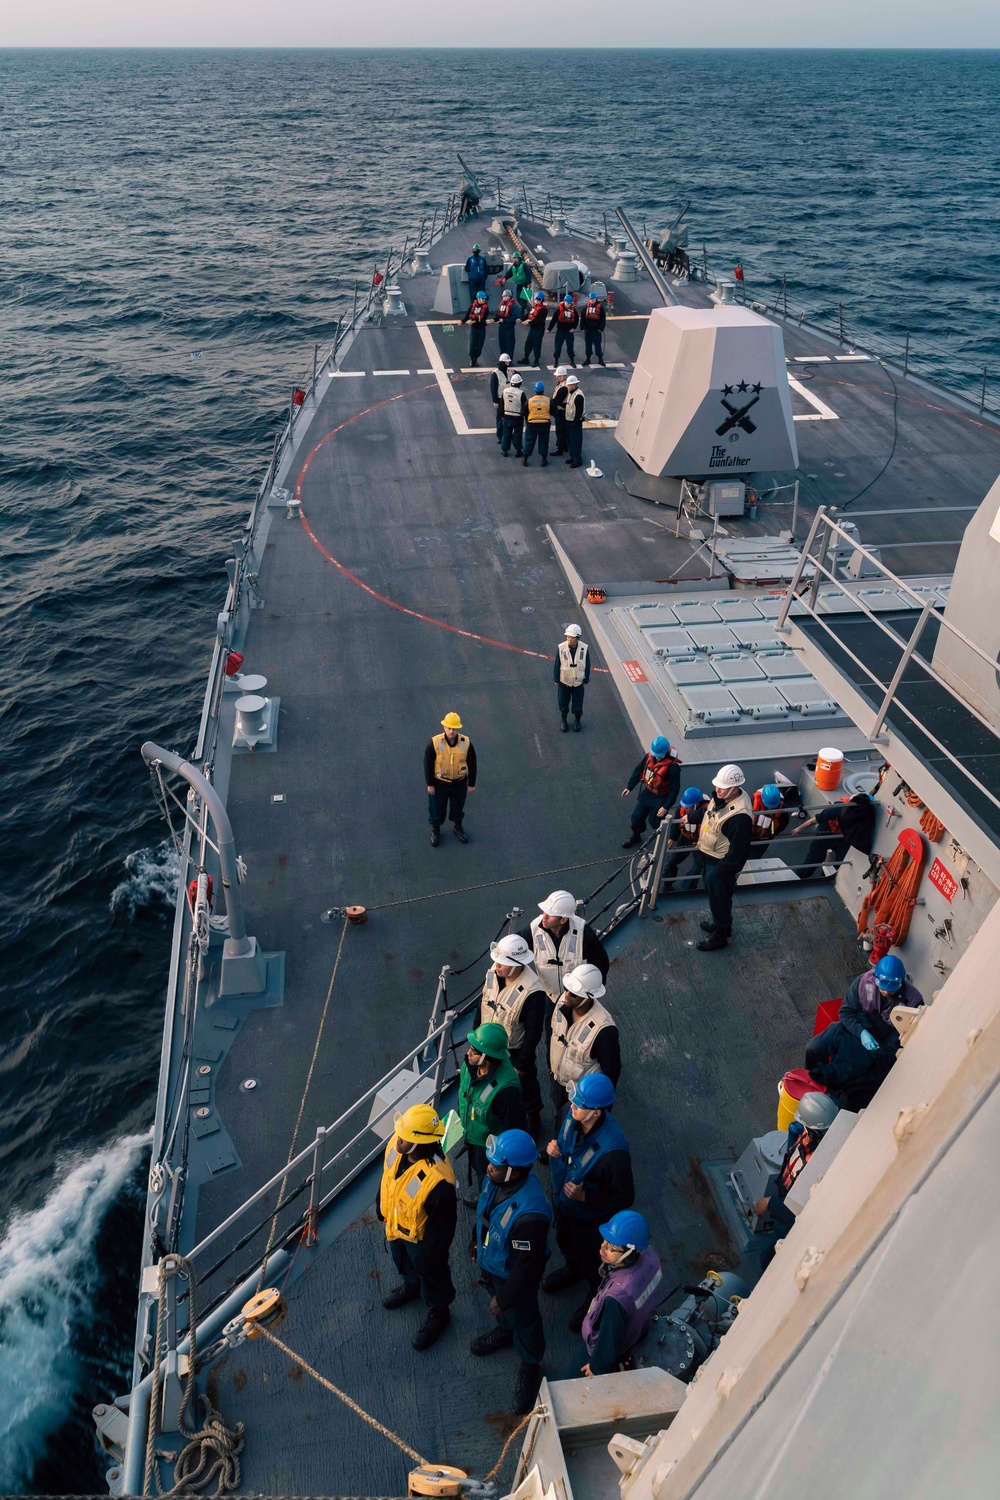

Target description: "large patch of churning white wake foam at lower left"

left=0, top=1136, right=148, bottom=1494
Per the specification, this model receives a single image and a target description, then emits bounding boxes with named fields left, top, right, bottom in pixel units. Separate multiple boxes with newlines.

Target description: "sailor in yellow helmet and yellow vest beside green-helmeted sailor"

left=378, top=1104, right=457, bottom=1350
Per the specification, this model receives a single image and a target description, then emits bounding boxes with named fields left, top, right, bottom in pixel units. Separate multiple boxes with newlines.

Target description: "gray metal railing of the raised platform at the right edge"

left=775, top=506, right=1000, bottom=810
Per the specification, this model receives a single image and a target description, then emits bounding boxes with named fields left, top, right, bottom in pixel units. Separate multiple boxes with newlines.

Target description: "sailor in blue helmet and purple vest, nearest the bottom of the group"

left=564, top=1209, right=664, bottom=1380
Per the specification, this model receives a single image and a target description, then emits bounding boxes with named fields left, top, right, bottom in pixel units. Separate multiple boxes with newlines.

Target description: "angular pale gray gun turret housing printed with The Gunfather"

left=615, top=303, right=799, bottom=515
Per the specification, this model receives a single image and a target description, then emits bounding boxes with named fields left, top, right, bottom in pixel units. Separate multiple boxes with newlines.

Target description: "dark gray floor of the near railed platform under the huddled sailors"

left=211, top=893, right=856, bottom=1496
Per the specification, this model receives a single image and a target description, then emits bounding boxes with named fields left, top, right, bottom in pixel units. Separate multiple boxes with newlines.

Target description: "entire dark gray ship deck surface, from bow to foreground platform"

left=138, top=205, right=1000, bottom=1494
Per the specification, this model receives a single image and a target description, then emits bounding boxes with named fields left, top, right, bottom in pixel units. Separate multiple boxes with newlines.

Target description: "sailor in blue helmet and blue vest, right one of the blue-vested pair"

left=541, top=1073, right=636, bottom=1331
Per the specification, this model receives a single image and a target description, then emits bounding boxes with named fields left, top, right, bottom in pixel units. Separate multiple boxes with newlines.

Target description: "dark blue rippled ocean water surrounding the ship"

left=0, top=51, right=1000, bottom=1493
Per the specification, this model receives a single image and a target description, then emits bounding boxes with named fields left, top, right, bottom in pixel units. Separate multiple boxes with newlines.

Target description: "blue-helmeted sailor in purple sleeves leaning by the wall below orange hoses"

left=805, top=953, right=924, bottom=1110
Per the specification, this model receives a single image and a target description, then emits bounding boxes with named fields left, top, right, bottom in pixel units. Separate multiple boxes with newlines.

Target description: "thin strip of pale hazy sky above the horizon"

left=0, top=0, right=1000, bottom=47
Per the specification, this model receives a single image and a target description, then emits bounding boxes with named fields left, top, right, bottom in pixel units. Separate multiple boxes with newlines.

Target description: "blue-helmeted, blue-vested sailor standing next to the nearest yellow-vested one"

left=469, top=1130, right=552, bottom=1415
